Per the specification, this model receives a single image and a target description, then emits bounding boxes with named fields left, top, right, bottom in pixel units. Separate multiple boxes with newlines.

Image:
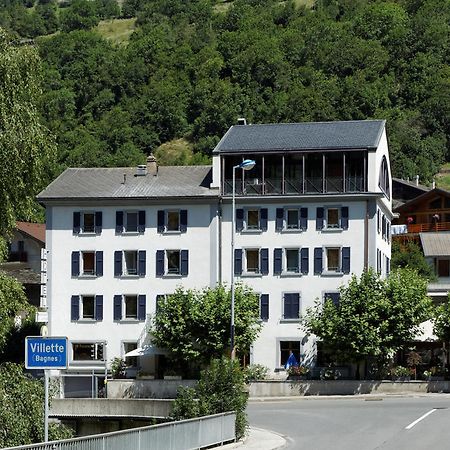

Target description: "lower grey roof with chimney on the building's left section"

left=37, top=166, right=218, bottom=203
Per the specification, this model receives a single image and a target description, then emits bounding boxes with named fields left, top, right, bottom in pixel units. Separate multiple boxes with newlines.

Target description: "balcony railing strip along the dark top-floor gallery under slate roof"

left=223, top=176, right=365, bottom=196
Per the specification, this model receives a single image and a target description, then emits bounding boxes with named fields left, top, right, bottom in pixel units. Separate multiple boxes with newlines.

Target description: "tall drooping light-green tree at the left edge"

left=0, top=29, right=55, bottom=256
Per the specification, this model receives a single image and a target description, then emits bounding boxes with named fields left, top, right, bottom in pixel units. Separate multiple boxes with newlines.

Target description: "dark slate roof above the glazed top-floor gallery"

left=213, top=120, right=385, bottom=153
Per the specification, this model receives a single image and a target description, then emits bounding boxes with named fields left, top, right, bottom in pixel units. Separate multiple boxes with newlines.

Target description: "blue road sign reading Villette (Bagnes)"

left=25, top=336, right=67, bottom=369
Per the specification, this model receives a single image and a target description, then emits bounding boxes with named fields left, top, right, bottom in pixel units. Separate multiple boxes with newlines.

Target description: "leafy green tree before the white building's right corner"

left=302, top=268, right=431, bottom=377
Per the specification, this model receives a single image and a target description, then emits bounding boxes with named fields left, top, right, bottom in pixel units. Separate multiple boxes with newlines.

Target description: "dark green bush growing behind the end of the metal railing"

left=172, top=357, right=248, bottom=439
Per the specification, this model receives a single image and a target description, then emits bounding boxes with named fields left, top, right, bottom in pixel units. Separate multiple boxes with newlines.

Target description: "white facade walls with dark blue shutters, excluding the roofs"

left=39, top=119, right=392, bottom=372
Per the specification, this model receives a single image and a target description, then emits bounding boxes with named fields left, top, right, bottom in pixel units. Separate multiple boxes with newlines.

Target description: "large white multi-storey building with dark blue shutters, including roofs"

left=38, top=120, right=392, bottom=390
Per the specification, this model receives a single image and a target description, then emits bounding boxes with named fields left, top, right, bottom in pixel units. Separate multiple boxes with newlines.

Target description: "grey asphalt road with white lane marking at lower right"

left=247, top=394, right=450, bottom=450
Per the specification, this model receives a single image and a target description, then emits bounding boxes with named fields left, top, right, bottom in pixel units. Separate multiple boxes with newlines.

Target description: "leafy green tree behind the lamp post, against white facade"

left=150, top=285, right=261, bottom=367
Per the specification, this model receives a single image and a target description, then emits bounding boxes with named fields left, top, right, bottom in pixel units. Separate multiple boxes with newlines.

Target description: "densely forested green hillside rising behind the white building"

left=0, top=0, right=450, bottom=181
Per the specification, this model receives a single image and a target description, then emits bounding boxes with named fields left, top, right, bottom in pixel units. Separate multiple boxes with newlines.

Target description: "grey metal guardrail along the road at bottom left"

left=3, top=412, right=236, bottom=450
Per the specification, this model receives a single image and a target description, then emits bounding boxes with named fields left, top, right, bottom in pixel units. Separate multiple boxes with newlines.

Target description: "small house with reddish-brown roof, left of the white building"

left=0, top=222, right=45, bottom=307
